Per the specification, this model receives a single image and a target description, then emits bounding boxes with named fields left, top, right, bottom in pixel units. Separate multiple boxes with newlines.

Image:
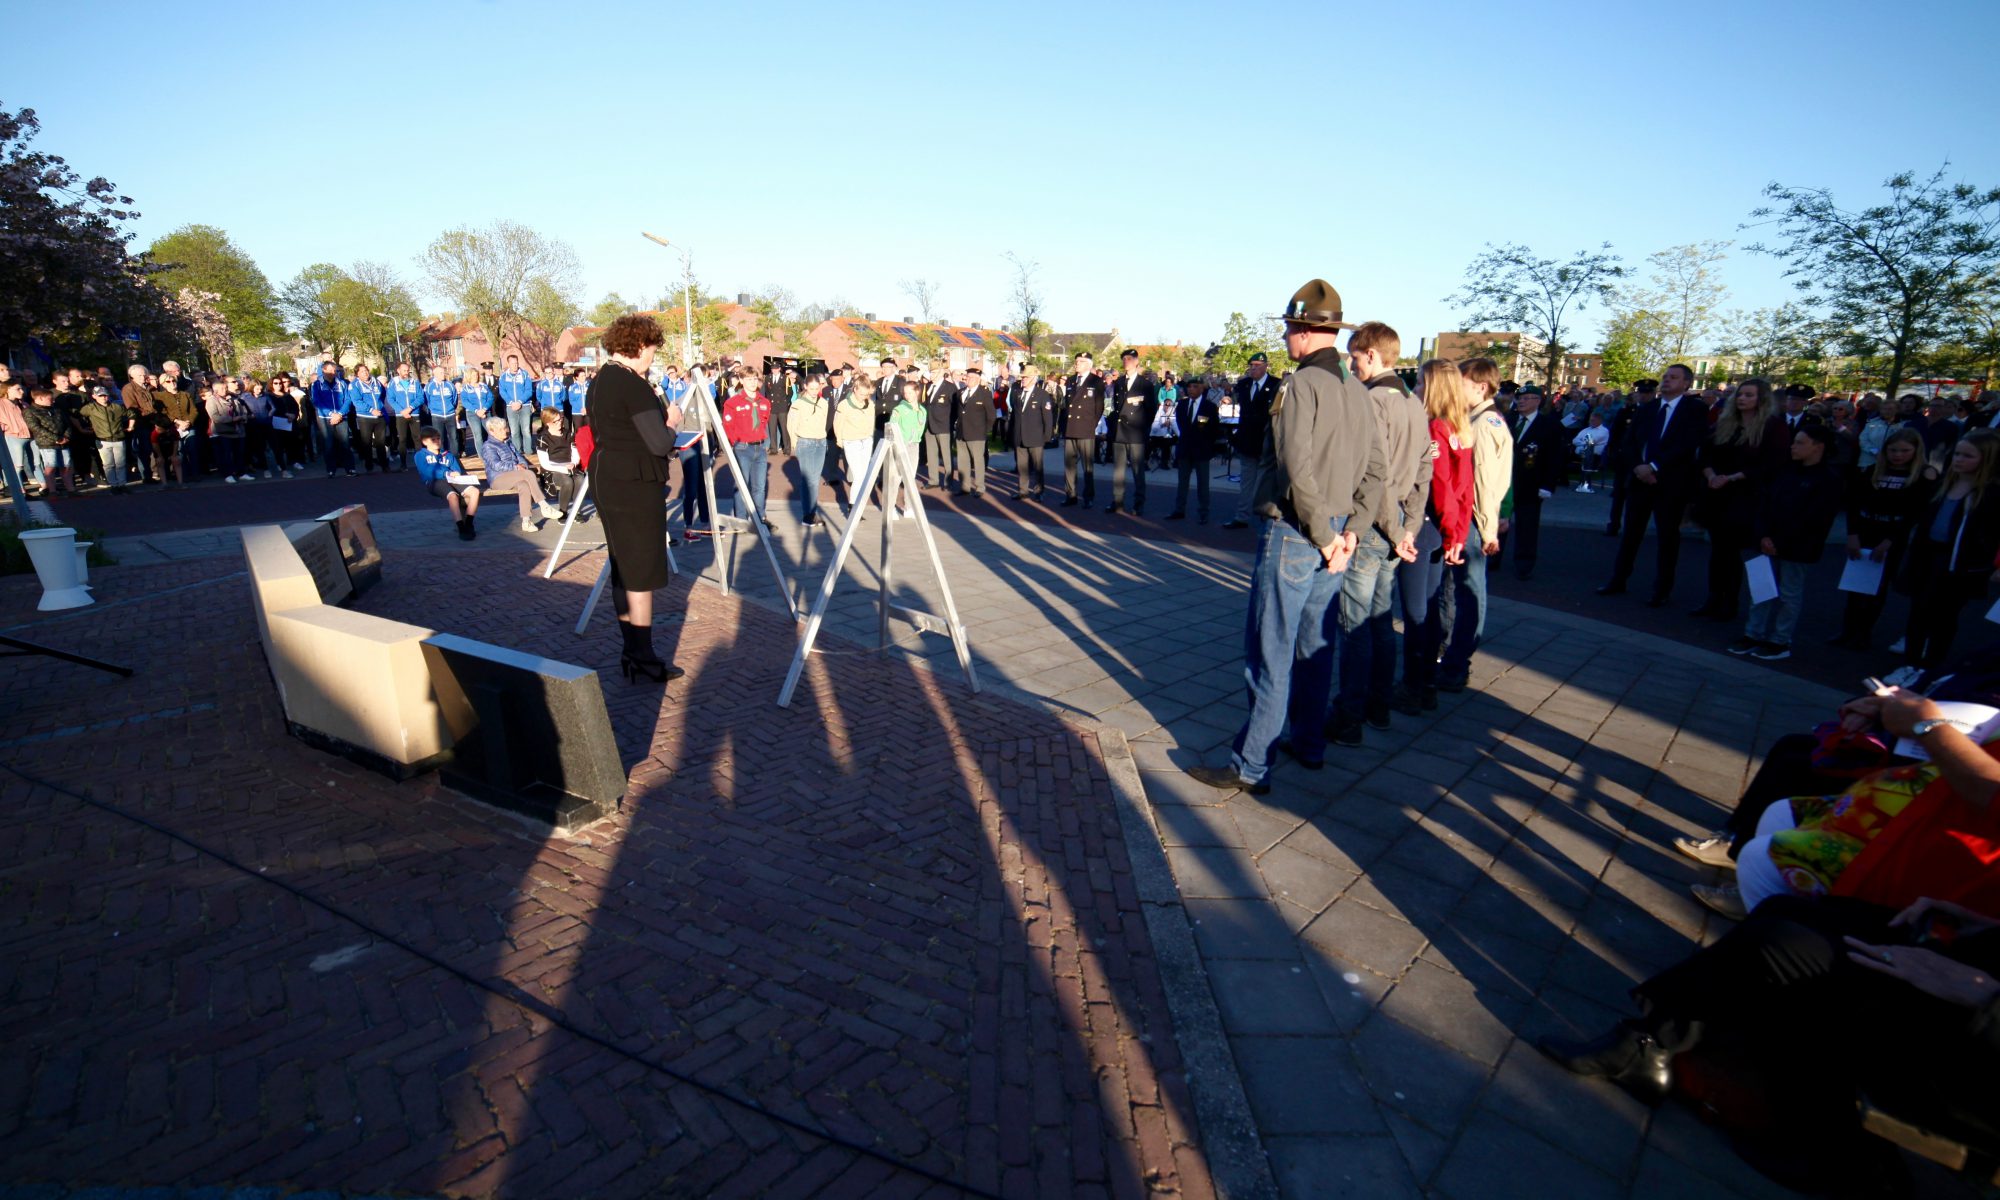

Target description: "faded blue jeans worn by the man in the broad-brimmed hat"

left=1230, top=518, right=1346, bottom=784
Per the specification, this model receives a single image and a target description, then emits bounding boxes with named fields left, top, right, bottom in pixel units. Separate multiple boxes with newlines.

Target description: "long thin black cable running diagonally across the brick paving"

left=0, top=762, right=1000, bottom=1200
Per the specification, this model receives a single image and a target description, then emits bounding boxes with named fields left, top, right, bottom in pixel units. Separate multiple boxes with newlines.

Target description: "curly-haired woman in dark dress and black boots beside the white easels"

left=586, top=314, right=686, bottom=684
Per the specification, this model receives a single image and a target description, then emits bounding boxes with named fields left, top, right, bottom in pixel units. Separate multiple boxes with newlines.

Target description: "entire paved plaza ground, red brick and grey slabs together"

left=0, top=474, right=1976, bottom=1198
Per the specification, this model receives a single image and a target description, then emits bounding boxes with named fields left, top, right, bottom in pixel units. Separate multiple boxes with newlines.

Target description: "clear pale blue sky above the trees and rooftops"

left=15, top=0, right=2000, bottom=346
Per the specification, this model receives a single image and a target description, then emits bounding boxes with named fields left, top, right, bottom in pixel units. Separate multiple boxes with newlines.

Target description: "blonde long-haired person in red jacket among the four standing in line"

left=1390, top=358, right=1474, bottom=714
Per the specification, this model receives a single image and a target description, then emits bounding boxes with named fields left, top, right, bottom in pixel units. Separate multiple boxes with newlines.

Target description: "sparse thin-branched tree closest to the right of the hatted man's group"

left=1444, top=242, right=1624, bottom=390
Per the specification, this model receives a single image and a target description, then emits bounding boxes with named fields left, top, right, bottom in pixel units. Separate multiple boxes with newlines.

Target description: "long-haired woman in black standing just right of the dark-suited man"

left=1694, top=380, right=1792, bottom=620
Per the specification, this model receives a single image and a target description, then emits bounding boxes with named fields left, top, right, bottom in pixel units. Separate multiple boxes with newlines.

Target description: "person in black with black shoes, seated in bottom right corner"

left=1536, top=896, right=2000, bottom=1196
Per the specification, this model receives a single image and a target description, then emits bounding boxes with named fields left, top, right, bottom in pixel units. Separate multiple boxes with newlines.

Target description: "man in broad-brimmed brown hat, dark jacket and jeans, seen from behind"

left=1188, top=280, right=1388, bottom=796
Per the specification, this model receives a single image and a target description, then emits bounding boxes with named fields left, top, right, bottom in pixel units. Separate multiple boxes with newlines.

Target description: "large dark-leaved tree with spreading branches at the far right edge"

left=1750, top=162, right=2000, bottom=396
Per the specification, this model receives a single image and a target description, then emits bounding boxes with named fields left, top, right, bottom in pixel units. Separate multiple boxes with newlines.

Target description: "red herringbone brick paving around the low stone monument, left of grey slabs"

left=0, top=552, right=1210, bottom=1196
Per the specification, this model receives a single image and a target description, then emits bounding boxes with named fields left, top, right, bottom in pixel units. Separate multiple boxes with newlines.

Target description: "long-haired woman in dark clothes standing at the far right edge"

left=1904, top=430, right=2000, bottom=672
